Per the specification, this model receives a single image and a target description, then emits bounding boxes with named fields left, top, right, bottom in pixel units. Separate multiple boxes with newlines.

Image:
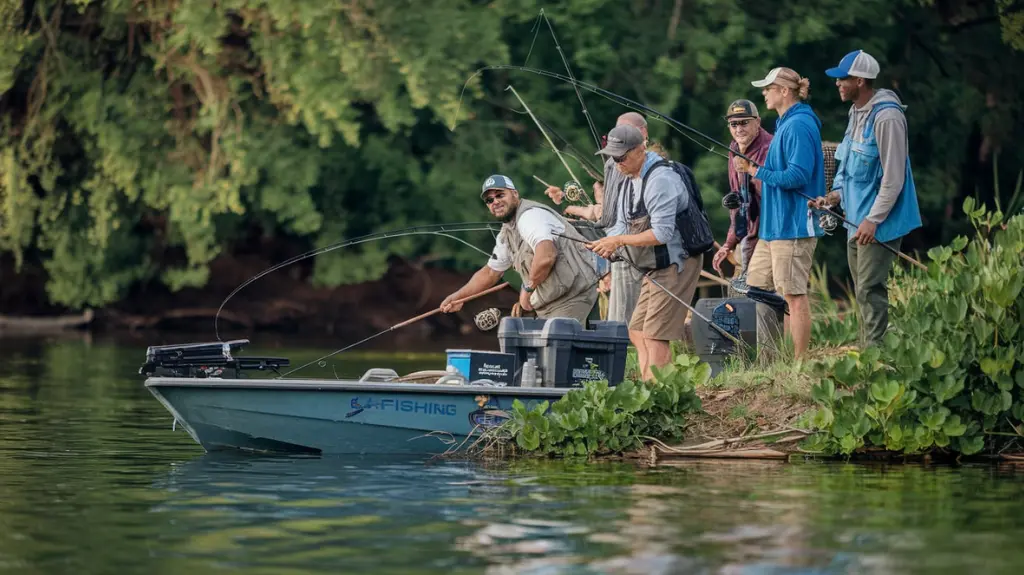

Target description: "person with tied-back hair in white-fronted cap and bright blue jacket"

left=733, top=68, right=825, bottom=359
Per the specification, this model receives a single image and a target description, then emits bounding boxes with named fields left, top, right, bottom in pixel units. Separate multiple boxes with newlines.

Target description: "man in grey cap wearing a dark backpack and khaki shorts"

left=589, top=124, right=703, bottom=380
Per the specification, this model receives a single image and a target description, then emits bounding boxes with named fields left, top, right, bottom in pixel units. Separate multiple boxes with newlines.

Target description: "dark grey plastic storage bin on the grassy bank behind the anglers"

left=690, top=297, right=783, bottom=375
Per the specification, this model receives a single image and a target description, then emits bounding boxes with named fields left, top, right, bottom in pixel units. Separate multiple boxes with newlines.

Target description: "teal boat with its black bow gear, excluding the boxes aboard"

left=139, top=340, right=568, bottom=454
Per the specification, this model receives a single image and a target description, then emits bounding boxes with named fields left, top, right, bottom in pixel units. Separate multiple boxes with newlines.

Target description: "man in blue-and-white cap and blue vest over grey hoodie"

left=814, top=50, right=921, bottom=345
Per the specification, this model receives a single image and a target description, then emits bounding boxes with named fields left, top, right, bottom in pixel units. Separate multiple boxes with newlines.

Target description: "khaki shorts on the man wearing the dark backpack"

left=630, top=255, right=703, bottom=341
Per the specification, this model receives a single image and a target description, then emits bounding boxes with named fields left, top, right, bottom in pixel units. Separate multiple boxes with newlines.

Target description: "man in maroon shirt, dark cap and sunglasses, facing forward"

left=712, top=99, right=772, bottom=274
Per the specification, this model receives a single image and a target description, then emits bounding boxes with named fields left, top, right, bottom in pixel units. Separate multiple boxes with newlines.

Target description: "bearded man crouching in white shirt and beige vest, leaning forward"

left=440, top=174, right=598, bottom=326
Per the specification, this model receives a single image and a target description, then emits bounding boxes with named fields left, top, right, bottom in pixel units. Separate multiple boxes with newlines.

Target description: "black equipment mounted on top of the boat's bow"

left=138, top=340, right=290, bottom=379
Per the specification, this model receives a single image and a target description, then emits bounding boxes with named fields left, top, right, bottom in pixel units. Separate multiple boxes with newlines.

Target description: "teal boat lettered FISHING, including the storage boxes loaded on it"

left=139, top=308, right=629, bottom=454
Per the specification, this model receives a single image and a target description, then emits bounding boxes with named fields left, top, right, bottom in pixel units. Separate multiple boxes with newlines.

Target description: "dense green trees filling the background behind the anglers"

left=0, top=0, right=1024, bottom=308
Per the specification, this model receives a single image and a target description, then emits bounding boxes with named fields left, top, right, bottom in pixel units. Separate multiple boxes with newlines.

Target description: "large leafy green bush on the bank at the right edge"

left=805, top=202, right=1024, bottom=455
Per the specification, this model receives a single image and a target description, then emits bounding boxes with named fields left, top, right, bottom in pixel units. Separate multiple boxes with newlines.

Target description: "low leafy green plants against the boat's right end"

left=496, top=355, right=711, bottom=457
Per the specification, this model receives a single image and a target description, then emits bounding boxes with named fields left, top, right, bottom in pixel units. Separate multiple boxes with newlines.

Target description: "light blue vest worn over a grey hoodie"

left=836, top=101, right=922, bottom=242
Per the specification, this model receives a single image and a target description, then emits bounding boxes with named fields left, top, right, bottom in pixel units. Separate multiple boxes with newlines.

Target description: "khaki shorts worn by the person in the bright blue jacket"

left=746, top=237, right=818, bottom=296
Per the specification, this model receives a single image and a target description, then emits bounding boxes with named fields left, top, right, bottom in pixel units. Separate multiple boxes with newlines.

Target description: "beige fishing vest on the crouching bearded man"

left=502, top=200, right=597, bottom=311
